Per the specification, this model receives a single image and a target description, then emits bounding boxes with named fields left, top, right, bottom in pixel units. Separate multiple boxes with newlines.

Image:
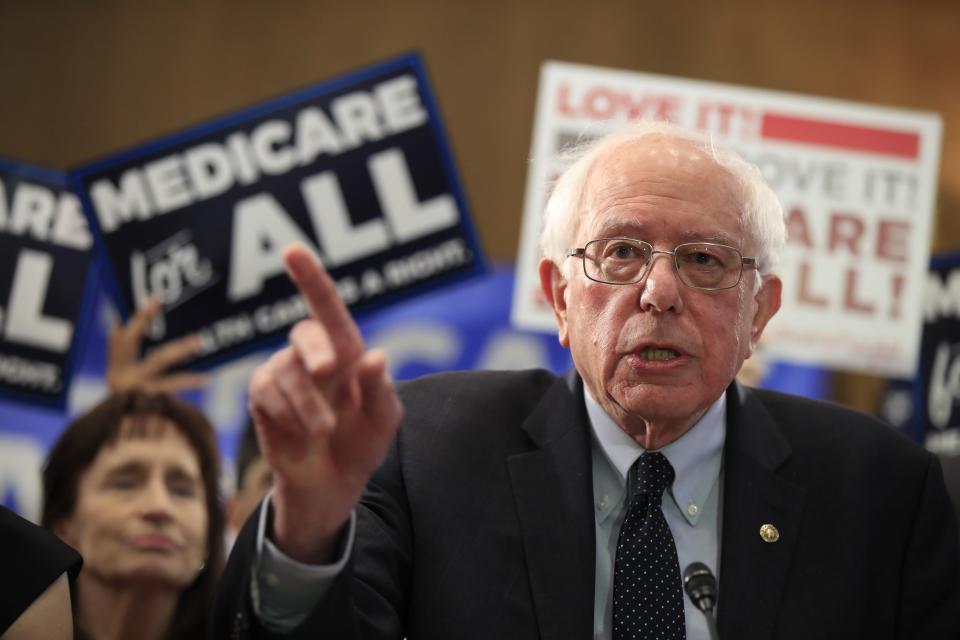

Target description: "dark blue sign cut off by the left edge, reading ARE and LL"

left=0, top=160, right=94, bottom=408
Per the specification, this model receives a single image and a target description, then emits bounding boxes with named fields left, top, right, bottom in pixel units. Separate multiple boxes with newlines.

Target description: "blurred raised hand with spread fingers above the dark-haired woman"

left=106, top=298, right=207, bottom=393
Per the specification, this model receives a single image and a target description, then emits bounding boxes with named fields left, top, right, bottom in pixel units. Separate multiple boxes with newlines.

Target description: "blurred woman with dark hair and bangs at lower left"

left=42, top=390, right=223, bottom=639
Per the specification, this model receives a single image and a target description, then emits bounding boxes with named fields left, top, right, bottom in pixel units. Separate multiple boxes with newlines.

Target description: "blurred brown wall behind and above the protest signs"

left=0, top=0, right=960, bottom=408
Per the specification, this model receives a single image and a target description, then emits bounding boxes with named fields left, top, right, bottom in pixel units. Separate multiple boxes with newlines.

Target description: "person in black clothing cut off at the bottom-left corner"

left=0, top=506, right=83, bottom=640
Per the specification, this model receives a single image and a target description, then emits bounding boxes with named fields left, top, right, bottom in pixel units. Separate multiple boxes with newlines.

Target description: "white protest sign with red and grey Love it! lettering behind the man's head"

left=512, top=62, right=942, bottom=377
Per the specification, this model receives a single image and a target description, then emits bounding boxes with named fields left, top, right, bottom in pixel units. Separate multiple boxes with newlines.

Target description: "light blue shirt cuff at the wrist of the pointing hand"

left=250, top=491, right=357, bottom=633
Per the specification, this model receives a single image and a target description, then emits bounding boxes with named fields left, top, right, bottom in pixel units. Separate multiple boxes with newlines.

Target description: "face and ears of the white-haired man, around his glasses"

left=541, top=136, right=780, bottom=448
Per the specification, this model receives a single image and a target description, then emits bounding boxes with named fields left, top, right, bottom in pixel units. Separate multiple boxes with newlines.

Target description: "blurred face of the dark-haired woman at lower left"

left=57, top=416, right=209, bottom=588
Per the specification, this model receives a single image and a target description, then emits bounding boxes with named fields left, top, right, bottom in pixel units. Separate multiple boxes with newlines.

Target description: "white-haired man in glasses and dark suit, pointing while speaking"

left=213, top=123, right=960, bottom=640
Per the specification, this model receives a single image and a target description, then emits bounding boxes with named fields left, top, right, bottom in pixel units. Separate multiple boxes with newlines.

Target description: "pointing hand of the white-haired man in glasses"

left=250, top=244, right=403, bottom=563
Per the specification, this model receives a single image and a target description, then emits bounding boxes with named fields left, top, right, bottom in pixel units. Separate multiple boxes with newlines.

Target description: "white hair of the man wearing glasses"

left=540, top=120, right=787, bottom=285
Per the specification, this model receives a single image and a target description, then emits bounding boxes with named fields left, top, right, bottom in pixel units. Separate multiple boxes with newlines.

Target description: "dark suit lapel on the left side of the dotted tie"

left=507, top=374, right=596, bottom=640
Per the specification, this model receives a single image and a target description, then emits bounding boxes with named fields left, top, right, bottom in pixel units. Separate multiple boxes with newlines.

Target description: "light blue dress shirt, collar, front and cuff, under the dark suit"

left=250, top=388, right=726, bottom=640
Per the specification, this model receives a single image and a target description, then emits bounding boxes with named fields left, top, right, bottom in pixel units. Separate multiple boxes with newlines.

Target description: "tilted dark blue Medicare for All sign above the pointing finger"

left=72, top=55, right=485, bottom=367
